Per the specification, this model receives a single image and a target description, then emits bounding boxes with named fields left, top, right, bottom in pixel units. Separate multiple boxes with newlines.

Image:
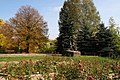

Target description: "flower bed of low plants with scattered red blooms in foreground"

left=0, top=56, right=120, bottom=80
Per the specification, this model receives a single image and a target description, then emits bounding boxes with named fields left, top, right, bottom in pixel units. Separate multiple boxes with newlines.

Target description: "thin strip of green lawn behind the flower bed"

left=0, top=56, right=120, bottom=62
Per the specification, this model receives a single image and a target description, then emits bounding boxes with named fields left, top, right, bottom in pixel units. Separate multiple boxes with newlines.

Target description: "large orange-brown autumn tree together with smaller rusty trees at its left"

left=0, top=5, right=48, bottom=53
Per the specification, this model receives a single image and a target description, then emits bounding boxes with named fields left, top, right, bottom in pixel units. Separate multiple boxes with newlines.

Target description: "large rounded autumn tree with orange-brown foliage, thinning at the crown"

left=10, top=5, right=48, bottom=53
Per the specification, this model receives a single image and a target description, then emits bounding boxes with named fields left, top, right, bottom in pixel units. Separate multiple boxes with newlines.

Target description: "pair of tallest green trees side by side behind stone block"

left=58, top=0, right=100, bottom=54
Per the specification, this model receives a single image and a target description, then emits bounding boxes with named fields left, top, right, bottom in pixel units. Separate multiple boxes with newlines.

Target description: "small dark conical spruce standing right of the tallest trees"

left=96, top=23, right=113, bottom=51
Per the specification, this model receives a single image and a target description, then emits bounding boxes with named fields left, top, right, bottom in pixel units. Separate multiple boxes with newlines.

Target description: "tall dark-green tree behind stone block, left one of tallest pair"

left=57, top=0, right=80, bottom=53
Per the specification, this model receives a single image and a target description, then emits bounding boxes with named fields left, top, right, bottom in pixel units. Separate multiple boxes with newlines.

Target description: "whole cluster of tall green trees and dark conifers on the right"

left=57, top=0, right=120, bottom=55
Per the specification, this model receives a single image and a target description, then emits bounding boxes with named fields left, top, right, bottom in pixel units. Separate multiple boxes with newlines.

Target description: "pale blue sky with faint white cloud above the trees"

left=0, top=0, right=120, bottom=39
